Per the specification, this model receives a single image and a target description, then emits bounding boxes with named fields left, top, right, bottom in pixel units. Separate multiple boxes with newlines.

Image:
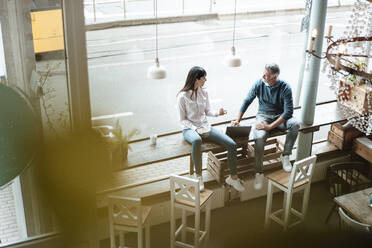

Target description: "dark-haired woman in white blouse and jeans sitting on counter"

left=177, top=66, right=244, bottom=192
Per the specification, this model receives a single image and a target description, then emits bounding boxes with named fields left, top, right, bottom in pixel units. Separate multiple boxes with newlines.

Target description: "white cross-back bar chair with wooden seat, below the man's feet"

left=265, top=155, right=316, bottom=230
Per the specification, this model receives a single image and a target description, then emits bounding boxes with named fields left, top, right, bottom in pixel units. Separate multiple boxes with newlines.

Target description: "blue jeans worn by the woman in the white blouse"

left=182, top=127, right=236, bottom=175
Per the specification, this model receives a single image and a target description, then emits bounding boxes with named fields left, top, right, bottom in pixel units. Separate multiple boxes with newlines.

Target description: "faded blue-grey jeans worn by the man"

left=253, top=113, right=300, bottom=173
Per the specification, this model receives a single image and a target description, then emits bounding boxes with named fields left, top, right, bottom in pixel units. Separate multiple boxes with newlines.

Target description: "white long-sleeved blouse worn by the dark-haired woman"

left=177, top=87, right=219, bottom=130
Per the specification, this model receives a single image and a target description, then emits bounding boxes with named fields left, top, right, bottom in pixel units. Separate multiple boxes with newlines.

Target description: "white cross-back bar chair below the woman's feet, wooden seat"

left=170, top=175, right=213, bottom=248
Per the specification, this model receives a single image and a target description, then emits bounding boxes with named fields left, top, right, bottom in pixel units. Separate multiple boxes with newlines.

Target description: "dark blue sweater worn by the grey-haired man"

left=240, top=79, right=293, bottom=120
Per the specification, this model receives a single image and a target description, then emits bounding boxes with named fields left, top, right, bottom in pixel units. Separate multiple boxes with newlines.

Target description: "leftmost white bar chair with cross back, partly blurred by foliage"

left=108, top=196, right=151, bottom=248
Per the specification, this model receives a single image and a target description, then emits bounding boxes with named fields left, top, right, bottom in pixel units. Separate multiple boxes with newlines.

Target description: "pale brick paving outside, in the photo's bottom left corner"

left=0, top=184, right=21, bottom=243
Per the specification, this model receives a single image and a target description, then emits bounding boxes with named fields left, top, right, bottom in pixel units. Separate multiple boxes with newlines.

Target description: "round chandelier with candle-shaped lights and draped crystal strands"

left=307, top=0, right=372, bottom=135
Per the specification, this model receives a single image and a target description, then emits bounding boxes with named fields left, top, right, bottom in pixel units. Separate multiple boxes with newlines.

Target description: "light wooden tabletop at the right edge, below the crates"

left=334, top=188, right=372, bottom=225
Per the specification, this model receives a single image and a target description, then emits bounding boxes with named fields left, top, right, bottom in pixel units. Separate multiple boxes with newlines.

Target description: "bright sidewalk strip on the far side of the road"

left=84, top=0, right=354, bottom=29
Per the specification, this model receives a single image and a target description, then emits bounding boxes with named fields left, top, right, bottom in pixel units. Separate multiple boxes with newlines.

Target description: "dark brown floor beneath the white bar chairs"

left=101, top=181, right=372, bottom=248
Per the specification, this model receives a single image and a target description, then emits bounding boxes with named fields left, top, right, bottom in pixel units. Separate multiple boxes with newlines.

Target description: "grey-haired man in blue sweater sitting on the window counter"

left=231, top=64, right=300, bottom=190
